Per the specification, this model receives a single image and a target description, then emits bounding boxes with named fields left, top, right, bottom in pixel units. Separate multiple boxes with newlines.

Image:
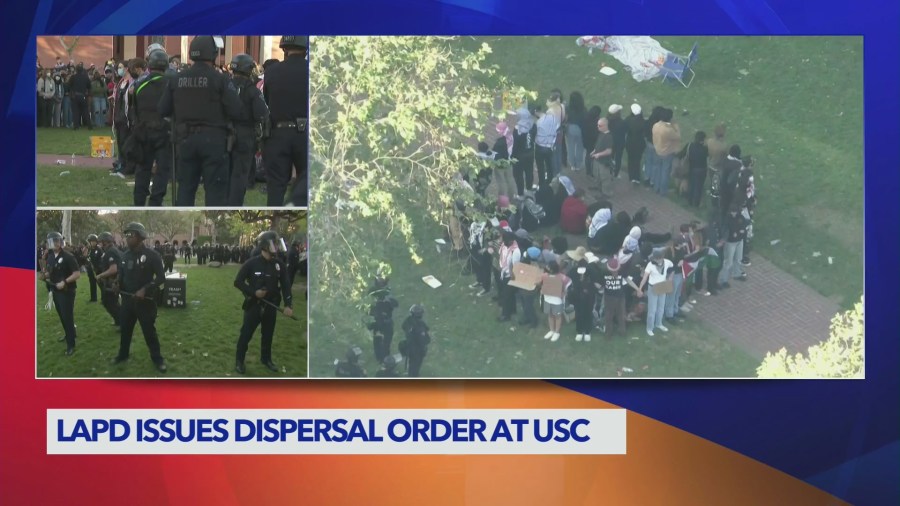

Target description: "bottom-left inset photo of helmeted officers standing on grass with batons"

left=35, top=210, right=307, bottom=378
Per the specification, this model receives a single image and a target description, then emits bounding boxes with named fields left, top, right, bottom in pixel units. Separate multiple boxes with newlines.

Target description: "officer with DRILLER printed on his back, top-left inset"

left=159, top=36, right=241, bottom=207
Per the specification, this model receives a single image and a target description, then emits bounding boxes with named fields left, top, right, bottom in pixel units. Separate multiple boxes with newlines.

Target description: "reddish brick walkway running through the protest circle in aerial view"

left=487, top=132, right=839, bottom=358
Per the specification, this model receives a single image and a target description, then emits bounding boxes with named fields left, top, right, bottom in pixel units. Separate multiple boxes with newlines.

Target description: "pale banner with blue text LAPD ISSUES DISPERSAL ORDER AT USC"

left=47, top=409, right=626, bottom=455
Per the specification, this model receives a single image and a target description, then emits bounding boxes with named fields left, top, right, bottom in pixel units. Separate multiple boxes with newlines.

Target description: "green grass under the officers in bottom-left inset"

left=37, top=259, right=307, bottom=378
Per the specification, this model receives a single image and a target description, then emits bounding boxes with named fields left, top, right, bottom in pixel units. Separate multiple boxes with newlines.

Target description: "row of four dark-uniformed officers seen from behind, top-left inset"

left=123, top=35, right=309, bottom=207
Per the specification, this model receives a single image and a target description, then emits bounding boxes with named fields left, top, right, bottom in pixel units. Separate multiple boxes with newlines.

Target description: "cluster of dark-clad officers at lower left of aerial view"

left=334, top=275, right=431, bottom=378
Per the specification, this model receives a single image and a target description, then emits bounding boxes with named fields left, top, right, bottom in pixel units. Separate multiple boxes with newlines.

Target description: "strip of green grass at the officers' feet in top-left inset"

left=37, top=165, right=266, bottom=207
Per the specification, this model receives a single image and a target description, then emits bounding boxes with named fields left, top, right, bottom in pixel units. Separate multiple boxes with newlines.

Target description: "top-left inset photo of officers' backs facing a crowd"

left=35, top=35, right=309, bottom=208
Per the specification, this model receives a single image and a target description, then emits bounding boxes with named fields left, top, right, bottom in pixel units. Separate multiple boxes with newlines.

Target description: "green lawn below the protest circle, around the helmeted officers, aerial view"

left=310, top=230, right=759, bottom=378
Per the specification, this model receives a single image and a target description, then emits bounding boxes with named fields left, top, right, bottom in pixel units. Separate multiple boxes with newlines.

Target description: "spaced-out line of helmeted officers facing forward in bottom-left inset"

left=40, top=222, right=293, bottom=374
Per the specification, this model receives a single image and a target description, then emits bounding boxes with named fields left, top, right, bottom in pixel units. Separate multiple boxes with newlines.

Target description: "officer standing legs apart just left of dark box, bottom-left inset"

left=113, top=223, right=167, bottom=372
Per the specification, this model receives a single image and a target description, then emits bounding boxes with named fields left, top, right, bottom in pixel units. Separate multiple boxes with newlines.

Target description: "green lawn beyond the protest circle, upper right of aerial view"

left=464, top=37, right=863, bottom=307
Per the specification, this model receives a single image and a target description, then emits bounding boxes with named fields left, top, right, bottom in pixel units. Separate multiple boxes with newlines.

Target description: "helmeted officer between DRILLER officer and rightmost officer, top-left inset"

left=228, top=54, right=269, bottom=207
